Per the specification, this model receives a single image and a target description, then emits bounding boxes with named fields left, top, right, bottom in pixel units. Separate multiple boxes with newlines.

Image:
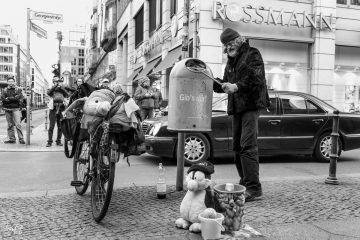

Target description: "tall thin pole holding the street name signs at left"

left=26, top=8, right=32, bottom=145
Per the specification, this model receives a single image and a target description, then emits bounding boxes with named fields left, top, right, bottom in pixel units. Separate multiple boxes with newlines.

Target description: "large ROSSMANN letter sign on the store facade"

left=212, top=0, right=335, bottom=31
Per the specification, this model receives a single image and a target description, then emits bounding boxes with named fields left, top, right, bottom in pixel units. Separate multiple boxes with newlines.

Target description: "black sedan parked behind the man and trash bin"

left=143, top=91, right=360, bottom=165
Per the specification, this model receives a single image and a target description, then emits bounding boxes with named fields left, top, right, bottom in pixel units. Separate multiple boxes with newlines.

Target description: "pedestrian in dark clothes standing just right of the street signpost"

left=46, top=77, right=68, bottom=147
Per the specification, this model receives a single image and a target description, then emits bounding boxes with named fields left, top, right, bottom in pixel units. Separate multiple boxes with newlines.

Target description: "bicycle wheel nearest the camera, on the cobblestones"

left=91, top=139, right=117, bottom=222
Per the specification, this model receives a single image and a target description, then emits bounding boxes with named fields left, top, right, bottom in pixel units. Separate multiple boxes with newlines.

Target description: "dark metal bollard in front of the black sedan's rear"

left=325, top=110, right=339, bottom=185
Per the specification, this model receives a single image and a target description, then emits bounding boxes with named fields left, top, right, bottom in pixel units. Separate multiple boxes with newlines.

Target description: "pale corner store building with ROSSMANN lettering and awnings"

left=92, top=0, right=360, bottom=111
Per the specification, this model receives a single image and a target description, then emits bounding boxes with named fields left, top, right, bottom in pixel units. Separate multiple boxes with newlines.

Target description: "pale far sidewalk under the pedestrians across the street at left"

left=0, top=123, right=64, bottom=152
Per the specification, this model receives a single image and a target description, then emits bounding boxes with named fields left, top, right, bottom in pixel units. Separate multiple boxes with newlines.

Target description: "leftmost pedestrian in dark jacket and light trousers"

left=1, top=76, right=25, bottom=144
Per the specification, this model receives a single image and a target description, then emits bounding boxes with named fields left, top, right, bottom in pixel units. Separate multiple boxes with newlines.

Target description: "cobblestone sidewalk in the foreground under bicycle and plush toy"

left=0, top=175, right=360, bottom=240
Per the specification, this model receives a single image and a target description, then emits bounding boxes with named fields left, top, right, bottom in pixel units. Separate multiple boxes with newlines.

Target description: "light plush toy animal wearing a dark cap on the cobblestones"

left=175, top=161, right=214, bottom=232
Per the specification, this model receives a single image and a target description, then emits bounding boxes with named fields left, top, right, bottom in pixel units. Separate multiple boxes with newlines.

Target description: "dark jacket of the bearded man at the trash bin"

left=214, top=42, right=270, bottom=115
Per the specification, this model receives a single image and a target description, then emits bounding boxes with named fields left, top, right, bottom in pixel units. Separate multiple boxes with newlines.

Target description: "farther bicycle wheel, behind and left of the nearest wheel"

left=73, top=141, right=90, bottom=195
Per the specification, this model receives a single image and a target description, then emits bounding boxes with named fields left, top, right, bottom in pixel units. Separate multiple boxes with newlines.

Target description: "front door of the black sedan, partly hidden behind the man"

left=258, top=92, right=282, bottom=153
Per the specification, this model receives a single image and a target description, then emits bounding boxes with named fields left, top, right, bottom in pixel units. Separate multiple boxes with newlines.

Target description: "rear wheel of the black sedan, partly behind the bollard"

left=315, top=132, right=342, bottom=162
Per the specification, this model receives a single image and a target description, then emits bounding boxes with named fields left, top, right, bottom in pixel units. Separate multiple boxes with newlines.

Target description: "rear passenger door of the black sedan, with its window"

left=280, top=93, right=328, bottom=152
